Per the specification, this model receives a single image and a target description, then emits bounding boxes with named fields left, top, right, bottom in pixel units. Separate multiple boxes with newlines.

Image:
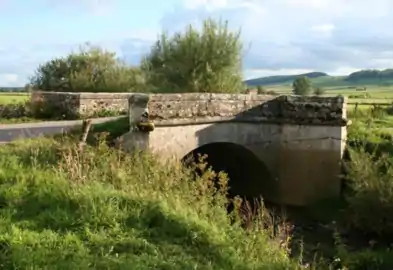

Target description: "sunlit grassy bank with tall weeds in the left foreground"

left=0, top=139, right=295, bottom=270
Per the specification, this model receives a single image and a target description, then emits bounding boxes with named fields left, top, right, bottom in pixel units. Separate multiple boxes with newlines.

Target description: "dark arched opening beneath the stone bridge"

left=182, top=142, right=272, bottom=206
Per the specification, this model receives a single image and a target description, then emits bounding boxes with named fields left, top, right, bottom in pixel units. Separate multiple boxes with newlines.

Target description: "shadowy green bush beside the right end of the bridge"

left=346, top=150, right=393, bottom=237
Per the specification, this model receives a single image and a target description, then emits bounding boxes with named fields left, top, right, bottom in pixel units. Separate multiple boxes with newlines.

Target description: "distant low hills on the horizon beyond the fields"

left=244, top=69, right=393, bottom=87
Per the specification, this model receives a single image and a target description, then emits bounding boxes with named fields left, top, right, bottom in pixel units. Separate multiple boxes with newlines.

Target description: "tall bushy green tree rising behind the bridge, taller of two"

left=142, top=19, right=244, bottom=92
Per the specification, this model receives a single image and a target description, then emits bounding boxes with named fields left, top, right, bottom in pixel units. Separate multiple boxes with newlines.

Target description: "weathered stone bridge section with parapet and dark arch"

left=119, top=93, right=347, bottom=206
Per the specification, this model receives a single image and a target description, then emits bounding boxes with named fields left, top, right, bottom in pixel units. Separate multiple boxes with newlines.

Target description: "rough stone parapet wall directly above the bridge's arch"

left=144, top=93, right=347, bottom=126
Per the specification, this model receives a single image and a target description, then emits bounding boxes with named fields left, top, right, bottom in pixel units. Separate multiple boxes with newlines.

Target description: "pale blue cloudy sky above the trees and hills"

left=0, top=0, right=393, bottom=86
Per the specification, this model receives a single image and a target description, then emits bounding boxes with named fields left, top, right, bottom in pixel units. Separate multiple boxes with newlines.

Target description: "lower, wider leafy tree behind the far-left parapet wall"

left=30, top=45, right=144, bottom=92
